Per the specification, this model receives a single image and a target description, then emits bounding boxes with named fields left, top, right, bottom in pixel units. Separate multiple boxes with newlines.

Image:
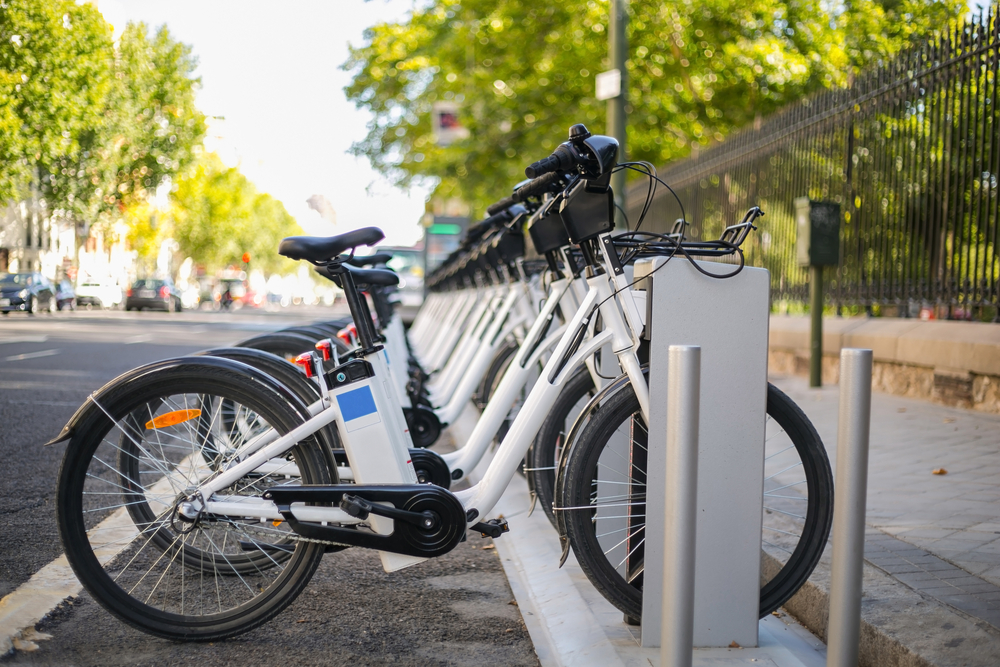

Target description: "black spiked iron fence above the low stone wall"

left=628, top=7, right=1000, bottom=319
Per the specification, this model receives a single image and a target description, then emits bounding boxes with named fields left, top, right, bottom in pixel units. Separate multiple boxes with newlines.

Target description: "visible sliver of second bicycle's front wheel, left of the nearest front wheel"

left=527, top=368, right=597, bottom=528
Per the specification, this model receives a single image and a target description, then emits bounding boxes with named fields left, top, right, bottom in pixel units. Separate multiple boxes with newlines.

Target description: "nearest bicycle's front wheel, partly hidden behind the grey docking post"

left=560, top=384, right=833, bottom=619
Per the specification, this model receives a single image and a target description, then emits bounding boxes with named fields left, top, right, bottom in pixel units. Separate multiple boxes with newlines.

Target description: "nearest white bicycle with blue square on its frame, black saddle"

left=54, top=126, right=832, bottom=641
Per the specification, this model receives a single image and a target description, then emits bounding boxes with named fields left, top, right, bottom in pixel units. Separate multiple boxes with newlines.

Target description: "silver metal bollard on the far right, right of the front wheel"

left=826, top=349, right=872, bottom=667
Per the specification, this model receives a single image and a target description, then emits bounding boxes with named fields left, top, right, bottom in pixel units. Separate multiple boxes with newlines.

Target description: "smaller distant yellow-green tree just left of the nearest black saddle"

left=171, top=154, right=302, bottom=272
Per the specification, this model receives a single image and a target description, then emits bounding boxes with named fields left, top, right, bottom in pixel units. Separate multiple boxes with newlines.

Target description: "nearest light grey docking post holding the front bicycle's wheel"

left=636, top=257, right=770, bottom=647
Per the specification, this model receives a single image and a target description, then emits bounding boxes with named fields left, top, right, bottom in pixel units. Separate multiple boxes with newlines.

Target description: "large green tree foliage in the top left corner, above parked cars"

left=0, top=0, right=205, bottom=220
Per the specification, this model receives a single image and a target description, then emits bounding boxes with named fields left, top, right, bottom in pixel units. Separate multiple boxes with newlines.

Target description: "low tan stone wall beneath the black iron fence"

left=768, top=315, right=1000, bottom=414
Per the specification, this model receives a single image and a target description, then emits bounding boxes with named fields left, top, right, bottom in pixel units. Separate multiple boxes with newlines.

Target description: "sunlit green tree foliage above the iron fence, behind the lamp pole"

left=344, top=0, right=965, bottom=217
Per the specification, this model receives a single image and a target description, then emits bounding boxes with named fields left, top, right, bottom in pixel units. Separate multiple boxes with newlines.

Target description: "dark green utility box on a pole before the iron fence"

left=794, top=197, right=840, bottom=387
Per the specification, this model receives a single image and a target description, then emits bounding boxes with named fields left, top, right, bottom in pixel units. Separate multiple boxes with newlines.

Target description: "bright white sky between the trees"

left=96, top=0, right=427, bottom=245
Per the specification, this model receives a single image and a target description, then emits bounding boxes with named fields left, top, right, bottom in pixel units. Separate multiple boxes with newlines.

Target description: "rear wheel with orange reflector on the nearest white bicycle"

left=57, top=362, right=329, bottom=641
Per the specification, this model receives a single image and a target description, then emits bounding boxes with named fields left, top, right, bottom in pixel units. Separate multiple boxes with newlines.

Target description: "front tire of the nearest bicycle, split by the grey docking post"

left=560, top=383, right=833, bottom=619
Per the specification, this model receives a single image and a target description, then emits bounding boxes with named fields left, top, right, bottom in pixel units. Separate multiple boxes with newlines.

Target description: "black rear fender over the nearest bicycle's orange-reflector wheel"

left=42, top=357, right=309, bottom=447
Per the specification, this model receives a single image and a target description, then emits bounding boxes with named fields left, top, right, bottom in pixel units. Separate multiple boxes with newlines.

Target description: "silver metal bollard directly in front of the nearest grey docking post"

left=660, top=345, right=701, bottom=667
